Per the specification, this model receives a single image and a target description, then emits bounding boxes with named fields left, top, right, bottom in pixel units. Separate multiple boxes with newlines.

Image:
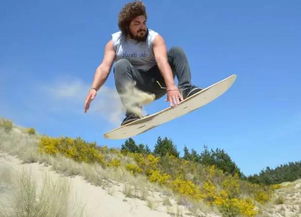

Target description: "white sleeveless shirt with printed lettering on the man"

left=112, top=29, right=158, bottom=71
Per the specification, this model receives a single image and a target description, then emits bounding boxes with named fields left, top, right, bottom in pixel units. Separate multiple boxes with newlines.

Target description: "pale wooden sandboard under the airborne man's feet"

left=104, top=74, right=236, bottom=139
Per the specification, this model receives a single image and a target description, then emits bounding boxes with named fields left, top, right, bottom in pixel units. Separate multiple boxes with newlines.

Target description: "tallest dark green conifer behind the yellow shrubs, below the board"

left=154, top=137, right=179, bottom=158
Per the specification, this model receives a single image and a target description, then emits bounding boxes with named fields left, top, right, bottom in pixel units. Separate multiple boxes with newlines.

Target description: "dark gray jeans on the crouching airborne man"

left=114, top=47, right=191, bottom=107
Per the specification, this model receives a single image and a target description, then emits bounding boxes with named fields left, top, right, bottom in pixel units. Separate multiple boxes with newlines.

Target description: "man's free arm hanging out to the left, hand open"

left=84, top=40, right=116, bottom=112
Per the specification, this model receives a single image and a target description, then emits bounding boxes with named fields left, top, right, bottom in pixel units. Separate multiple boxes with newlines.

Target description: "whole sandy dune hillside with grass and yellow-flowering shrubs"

left=0, top=119, right=301, bottom=217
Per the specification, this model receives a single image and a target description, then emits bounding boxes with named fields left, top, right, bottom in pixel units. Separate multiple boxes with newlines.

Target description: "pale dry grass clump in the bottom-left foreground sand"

left=0, top=170, right=83, bottom=217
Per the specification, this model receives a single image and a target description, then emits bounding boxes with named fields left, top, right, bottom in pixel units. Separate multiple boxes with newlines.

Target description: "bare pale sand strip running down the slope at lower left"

left=0, top=154, right=169, bottom=217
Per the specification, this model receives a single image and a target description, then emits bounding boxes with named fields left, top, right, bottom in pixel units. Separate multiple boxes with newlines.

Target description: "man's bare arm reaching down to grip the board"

left=153, top=35, right=183, bottom=106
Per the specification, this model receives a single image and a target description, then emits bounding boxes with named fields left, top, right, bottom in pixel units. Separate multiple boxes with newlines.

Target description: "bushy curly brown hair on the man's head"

left=118, top=0, right=147, bottom=35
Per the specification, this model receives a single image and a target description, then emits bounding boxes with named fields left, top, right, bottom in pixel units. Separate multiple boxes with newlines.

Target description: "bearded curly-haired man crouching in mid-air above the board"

left=84, top=1, right=201, bottom=125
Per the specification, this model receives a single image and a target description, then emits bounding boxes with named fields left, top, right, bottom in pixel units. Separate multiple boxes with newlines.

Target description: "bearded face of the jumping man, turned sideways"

left=129, top=15, right=148, bottom=41
